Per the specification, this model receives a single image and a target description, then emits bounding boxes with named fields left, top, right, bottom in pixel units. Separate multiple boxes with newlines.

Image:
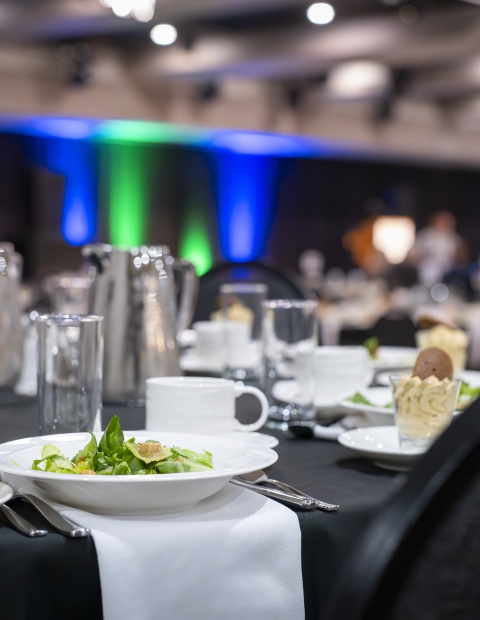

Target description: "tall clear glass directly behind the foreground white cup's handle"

left=263, top=299, right=318, bottom=430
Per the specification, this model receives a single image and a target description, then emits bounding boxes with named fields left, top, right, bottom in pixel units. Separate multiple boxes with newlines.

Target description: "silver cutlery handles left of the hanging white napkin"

left=0, top=482, right=91, bottom=538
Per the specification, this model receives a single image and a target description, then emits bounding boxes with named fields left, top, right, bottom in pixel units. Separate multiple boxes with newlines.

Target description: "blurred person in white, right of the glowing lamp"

left=409, top=211, right=468, bottom=287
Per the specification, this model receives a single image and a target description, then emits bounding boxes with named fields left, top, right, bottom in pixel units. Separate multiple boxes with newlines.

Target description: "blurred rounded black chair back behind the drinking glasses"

left=193, top=262, right=305, bottom=322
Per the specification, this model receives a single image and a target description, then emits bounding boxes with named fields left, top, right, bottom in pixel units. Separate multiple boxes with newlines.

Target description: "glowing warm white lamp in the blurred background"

left=373, top=215, right=415, bottom=265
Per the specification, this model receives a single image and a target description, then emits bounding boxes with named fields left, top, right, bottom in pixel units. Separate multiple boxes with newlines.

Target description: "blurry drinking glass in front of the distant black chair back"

left=220, top=283, right=268, bottom=382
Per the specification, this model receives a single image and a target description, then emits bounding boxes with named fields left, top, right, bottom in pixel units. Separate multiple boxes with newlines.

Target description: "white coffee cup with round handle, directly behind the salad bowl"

left=146, top=377, right=269, bottom=435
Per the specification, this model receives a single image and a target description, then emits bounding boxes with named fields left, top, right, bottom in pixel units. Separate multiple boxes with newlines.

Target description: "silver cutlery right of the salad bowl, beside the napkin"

left=230, top=469, right=340, bottom=512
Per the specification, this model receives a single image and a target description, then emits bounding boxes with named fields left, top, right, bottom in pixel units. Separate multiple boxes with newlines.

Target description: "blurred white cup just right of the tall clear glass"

left=313, top=346, right=373, bottom=406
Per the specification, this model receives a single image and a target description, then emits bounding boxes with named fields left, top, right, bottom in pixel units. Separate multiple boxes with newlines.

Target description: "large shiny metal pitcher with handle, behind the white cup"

left=82, top=244, right=197, bottom=404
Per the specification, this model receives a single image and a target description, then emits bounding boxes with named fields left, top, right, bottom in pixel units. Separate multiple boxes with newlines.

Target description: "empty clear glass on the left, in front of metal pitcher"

left=36, top=314, right=103, bottom=435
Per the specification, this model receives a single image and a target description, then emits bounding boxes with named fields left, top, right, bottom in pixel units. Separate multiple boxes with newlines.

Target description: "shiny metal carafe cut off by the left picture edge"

left=0, top=243, right=23, bottom=387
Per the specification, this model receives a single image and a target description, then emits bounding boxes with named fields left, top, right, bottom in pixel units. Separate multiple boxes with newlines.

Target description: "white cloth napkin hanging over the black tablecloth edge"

left=61, top=484, right=305, bottom=620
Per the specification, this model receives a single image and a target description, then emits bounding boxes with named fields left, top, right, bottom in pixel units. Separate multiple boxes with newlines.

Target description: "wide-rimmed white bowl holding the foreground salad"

left=0, top=431, right=278, bottom=515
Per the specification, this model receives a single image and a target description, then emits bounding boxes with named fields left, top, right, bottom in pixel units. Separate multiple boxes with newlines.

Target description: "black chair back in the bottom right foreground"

left=319, top=400, right=480, bottom=620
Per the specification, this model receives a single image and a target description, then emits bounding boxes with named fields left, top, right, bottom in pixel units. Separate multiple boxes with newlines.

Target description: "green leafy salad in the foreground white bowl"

left=32, top=416, right=213, bottom=476
